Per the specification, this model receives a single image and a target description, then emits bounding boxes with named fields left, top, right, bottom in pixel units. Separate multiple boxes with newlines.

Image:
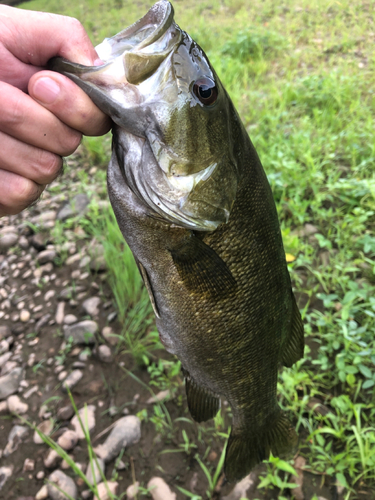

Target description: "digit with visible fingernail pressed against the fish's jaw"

left=28, top=71, right=111, bottom=135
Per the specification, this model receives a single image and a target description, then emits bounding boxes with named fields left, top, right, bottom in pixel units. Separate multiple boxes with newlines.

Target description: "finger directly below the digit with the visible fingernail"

left=0, top=82, right=81, bottom=156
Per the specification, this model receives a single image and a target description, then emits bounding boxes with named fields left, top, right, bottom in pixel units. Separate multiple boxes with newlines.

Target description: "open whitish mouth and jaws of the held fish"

left=48, top=0, right=182, bottom=132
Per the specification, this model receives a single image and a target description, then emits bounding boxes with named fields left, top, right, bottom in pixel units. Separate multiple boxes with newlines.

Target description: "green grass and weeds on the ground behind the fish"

left=16, top=0, right=375, bottom=500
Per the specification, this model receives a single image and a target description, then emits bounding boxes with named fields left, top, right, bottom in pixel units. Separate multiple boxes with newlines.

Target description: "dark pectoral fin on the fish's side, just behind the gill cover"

left=171, top=233, right=236, bottom=298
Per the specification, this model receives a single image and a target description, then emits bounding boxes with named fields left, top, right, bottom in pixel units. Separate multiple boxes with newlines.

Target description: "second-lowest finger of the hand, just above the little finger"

left=0, top=132, right=63, bottom=184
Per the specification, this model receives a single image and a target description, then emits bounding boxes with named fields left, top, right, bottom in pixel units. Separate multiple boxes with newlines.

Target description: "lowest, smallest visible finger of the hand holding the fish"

left=0, top=170, right=44, bottom=217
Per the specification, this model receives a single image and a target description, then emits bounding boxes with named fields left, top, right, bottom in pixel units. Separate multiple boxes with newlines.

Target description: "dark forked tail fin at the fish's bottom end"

left=224, top=410, right=298, bottom=482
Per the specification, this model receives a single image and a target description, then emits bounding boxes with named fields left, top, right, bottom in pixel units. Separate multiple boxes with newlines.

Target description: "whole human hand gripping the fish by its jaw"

left=0, top=5, right=111, bottom=217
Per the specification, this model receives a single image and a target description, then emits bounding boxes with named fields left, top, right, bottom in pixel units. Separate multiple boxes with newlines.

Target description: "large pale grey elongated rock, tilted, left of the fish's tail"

left=94, top=415, right=141, bottom=462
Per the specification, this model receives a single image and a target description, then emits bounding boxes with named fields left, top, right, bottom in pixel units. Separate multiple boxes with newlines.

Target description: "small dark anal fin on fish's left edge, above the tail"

left=183, top=370, right=220, bottom=422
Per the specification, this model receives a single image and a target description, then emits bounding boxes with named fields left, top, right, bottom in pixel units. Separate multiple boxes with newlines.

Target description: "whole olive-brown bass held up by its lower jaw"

left=50, top=0, right=304, bottom=482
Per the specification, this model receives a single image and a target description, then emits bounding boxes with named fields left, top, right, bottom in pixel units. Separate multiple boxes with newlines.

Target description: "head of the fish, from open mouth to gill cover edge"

left=51, top=0, right=240, bottom=231
